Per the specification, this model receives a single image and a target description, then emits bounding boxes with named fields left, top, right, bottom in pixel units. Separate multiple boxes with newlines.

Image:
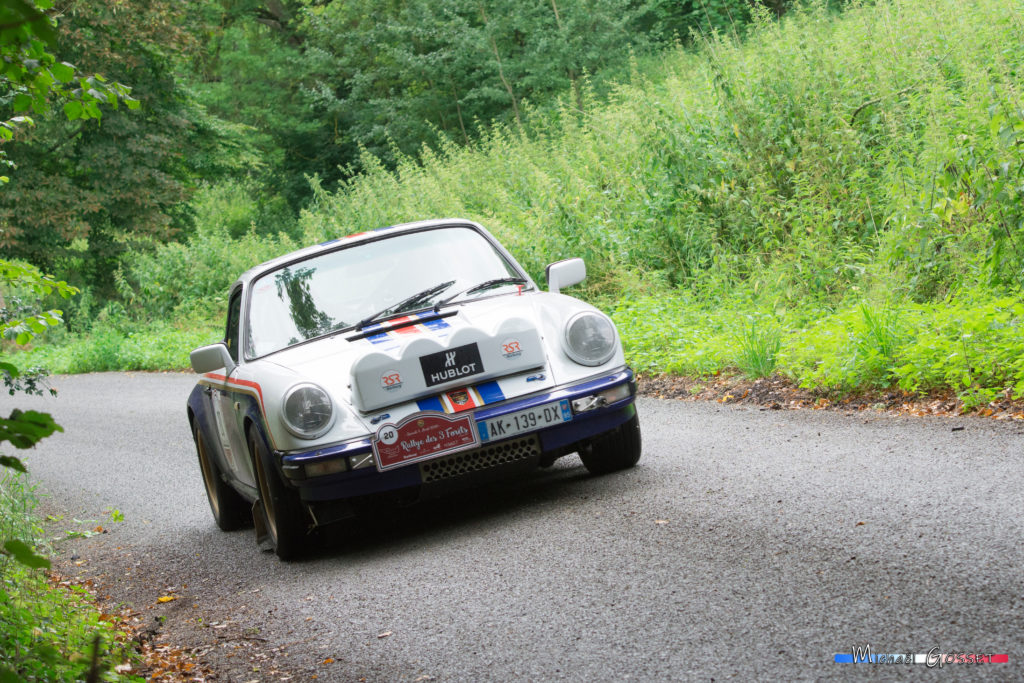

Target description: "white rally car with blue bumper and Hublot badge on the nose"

left=188, top=219, right=640, bottom=558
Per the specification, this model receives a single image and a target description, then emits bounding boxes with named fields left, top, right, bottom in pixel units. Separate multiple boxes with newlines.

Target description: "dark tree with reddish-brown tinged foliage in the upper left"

left=0, top=0, right=252, bottom=298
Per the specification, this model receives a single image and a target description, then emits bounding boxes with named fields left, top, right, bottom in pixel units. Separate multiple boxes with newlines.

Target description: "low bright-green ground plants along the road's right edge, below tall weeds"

left=612, top=291, right=1024, bottom=408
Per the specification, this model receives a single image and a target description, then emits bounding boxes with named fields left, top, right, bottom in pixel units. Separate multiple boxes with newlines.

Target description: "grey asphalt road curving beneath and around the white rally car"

left=9, top=374, right=1024, bottom=681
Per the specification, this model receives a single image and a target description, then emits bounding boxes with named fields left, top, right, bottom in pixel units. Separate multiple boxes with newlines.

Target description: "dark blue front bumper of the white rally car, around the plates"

left=279, top=368, right=636, bottom=503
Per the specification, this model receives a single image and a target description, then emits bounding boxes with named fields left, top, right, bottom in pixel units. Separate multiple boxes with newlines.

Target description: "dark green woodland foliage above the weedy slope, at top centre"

left=194, top=0, right=686, bottom=209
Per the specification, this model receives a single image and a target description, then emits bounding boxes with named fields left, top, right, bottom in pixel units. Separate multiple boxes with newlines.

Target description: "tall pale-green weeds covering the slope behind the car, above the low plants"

left=278, top=0, right=1022, bottom=305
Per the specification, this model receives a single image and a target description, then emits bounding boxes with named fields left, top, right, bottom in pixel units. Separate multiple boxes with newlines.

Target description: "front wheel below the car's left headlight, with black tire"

left=248, top=425, right=306, bottom=560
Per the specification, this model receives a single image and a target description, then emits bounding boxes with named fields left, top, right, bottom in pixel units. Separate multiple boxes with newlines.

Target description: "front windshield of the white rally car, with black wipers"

left=246, top=227, right=521, bottom=358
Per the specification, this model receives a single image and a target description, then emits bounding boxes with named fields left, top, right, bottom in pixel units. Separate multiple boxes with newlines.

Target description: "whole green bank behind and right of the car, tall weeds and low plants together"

left=9, top=0, right=1024, bottom=405
